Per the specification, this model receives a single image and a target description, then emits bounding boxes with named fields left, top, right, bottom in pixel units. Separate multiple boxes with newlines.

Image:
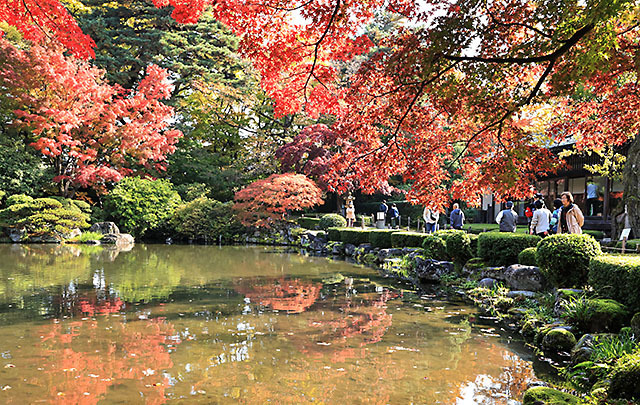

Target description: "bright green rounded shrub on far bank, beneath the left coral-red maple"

left=104, top=177, right=181, bottom=236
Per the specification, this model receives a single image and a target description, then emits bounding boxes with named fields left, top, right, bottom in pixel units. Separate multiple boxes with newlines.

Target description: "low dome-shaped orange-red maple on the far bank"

left=234, top=173, right=322, bottom=227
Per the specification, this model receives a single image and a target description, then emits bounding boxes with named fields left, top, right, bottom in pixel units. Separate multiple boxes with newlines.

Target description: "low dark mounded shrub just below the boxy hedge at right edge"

left=563, top=297, right=629, bottom=333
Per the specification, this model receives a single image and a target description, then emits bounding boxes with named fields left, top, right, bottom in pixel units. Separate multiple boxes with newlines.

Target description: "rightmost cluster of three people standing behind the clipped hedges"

left=496, top=191, right=584, bottom=237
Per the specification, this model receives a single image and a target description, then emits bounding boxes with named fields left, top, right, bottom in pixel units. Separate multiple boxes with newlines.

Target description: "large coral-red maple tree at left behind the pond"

left=0, top=40, right=181, bottom=196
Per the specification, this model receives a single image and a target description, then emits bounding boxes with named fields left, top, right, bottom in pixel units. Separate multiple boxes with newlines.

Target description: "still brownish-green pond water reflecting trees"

left=0, top=241, right=535, bottom=404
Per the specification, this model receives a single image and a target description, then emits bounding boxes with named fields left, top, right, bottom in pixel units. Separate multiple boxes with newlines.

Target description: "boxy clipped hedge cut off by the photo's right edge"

left=589, top=255, right=640, bottom=311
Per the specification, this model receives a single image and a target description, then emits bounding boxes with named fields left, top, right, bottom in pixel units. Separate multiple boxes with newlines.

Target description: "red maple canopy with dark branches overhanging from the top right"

left=3, top=0, right=640, bottom=227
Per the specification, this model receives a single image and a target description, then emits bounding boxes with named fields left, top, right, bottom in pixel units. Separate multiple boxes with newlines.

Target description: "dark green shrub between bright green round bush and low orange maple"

left=169, top=197, right=241, bottom=242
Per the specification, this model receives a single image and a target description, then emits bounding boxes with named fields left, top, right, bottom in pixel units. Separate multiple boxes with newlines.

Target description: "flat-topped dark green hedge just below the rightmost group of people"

left=478, top=232, right=540, bottom=266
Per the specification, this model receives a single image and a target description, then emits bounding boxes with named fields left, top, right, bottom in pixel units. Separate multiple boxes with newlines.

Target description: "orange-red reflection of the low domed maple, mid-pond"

left=235, top=278, right=322, bottom=314
